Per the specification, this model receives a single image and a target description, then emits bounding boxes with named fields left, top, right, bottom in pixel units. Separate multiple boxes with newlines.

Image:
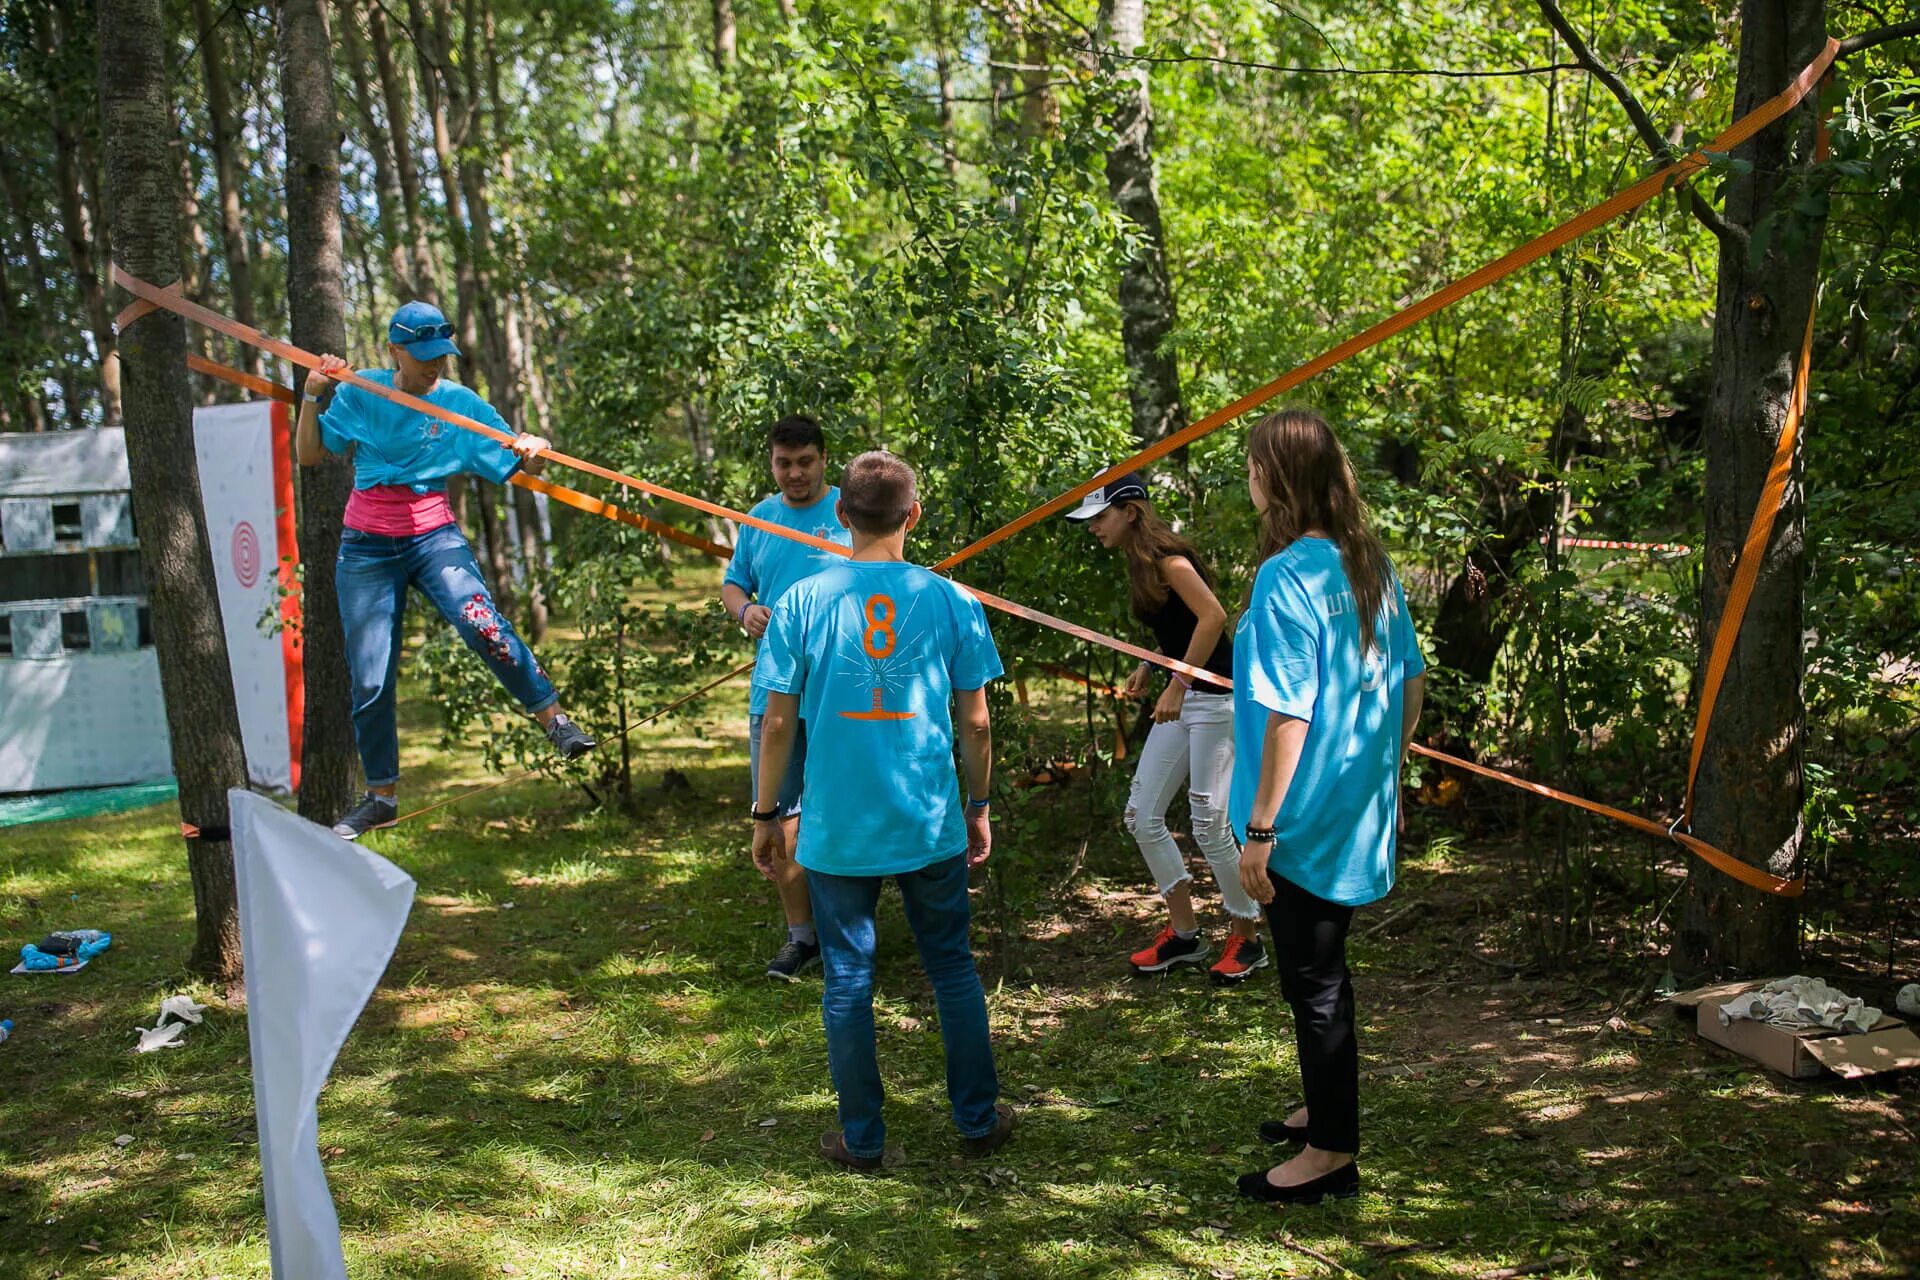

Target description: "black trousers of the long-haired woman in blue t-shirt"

left=1267, top=869, right=1359, bottom=1153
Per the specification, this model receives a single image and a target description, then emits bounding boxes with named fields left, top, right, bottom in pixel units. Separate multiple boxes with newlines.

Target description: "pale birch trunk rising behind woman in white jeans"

left=1100, top=0, right=1187, bottom=443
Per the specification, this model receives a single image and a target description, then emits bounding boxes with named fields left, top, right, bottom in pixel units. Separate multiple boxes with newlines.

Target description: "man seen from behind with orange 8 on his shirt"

left=753, top=451, right=1014, bottom=1171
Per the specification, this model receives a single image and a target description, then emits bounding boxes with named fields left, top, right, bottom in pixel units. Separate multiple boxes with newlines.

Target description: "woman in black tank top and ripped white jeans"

left=1068, top=472, right=1267, bottom=984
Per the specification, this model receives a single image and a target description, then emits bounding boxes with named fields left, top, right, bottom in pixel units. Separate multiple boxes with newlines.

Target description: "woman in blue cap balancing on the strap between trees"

left=296, top=301, right=593, bottom=841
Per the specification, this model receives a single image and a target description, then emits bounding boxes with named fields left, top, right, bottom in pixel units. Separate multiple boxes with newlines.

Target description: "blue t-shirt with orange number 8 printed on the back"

left=753, top=560, right=1000, bottom=875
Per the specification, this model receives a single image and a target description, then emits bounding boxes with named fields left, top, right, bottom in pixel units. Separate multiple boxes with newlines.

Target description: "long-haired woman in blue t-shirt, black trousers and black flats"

left=1229, top=409, right=1427, bottom=1203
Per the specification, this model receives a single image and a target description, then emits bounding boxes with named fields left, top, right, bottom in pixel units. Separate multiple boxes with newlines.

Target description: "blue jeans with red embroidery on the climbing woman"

left=334, top=524, right=561, bottom=787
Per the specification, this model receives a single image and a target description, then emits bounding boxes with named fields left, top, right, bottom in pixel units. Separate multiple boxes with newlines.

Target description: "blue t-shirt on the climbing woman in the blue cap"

left=321, top=368, right=520, bottom=493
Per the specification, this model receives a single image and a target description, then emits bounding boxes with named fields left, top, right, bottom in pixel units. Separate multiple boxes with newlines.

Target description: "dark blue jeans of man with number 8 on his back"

left=801, top=852, right=1000, bottom=1155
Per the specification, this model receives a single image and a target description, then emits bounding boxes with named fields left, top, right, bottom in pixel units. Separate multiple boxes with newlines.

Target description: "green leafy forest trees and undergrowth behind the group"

left=0, top=0, right=1920, bottom=973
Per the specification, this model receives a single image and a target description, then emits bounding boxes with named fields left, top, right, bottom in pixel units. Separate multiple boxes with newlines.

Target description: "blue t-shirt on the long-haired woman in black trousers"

left=1227, top=537, right=1427, bottom=906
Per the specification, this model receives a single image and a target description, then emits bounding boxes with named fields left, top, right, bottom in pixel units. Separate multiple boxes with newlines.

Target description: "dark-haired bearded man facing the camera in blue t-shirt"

left=720, top=415, right=849, bottom=983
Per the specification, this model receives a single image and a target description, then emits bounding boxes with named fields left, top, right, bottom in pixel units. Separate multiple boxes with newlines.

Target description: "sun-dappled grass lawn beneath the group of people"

left=0, top=606, right=1920, bottom=1280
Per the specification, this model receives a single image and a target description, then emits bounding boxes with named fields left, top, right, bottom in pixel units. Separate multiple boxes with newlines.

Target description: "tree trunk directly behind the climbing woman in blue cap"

left=276, top=0, right=355, bottom=821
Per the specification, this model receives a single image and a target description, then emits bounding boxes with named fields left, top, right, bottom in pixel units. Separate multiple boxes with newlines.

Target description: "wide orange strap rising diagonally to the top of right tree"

left=933, top=38, right=1839, bottom=570
